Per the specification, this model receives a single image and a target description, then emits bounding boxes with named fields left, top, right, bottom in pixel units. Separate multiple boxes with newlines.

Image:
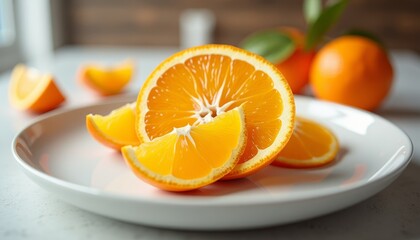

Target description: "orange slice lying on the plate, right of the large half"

left=272, top=117, right=339, bottom=168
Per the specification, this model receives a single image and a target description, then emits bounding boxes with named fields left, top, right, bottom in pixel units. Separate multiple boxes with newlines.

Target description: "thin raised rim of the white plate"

left=11, top=96, right=414, bottom=207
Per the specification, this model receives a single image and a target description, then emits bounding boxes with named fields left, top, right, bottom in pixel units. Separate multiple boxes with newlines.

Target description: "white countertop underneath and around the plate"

left=0, top=47, right=420, bottom=240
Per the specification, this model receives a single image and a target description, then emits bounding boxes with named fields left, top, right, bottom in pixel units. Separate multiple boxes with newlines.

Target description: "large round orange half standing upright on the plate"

left=136, top=45, right=295, bottom=179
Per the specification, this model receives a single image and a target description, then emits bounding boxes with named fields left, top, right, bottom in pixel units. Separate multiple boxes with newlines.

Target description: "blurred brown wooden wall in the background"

left=62, top=0, right=420, bottom=52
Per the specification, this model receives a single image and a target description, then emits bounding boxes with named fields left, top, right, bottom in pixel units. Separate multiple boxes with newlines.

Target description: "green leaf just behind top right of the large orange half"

left=239, top=30, right=296, bottom=63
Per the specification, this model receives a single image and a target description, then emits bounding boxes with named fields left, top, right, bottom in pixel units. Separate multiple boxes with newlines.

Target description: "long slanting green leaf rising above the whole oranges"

left=305, top=0, right=348, bottom=51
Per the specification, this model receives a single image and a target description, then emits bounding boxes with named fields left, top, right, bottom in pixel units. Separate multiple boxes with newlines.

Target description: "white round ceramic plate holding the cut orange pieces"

left=12, top=97, right=413, bottom=230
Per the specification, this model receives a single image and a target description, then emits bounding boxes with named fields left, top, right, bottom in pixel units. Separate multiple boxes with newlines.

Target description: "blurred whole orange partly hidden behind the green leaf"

left=275, top=27, right=315, bottom=93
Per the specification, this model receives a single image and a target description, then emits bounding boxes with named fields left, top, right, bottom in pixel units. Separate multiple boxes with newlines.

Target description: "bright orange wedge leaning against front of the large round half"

left=122, top=108, right=246, bottom=191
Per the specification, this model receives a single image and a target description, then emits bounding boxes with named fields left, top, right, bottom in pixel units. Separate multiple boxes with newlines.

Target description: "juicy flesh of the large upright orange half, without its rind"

left=145, top=54, right=283, bottom=162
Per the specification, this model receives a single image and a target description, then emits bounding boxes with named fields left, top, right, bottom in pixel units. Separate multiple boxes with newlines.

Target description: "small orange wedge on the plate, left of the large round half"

left=86, top=103, right=140, bottom=150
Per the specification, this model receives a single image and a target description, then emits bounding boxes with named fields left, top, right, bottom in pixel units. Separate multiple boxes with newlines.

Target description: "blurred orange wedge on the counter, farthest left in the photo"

left=9, top=64, right=65, bottom=113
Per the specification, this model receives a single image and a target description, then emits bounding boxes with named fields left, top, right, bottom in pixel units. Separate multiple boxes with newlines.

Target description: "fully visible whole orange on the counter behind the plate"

left=310, top=36, right=393, bottom=111
